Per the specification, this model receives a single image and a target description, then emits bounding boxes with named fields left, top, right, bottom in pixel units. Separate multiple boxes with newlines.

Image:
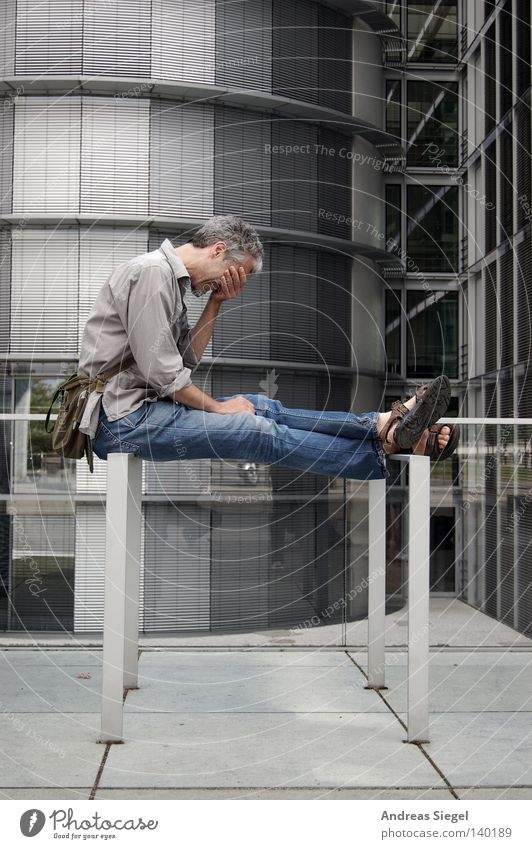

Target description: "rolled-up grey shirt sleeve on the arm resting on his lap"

left=112, top=265, right=197, bottom=398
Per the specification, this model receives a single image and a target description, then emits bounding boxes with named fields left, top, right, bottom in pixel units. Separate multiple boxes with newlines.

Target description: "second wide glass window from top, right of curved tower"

left=406, top=80, right=458, bottom=168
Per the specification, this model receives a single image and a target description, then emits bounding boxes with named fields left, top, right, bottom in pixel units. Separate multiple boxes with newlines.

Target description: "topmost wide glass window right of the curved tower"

left=407, top=0, right=458, bottom=63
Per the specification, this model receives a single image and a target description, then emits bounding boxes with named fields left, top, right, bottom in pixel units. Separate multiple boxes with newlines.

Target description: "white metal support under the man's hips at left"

left=99, top=453, right=142, bottom=743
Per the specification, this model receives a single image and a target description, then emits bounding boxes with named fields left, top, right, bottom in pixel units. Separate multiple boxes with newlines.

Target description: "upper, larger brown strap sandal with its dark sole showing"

left=379, top=374, right=451, bottom=451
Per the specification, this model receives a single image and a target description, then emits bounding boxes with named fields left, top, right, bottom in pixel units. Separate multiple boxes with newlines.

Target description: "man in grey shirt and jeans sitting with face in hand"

left=79, top=215, right=449, bottom=480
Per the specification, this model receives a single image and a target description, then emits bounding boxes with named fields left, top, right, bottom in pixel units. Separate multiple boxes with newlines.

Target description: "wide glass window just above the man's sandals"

left=406, top=290, right=458, bottom=378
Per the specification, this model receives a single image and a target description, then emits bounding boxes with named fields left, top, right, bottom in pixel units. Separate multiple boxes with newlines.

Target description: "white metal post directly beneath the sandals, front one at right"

left=407, top=455, right=430, bottom=743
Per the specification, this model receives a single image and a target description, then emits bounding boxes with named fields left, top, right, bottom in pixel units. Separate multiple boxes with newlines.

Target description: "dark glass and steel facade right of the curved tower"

left=384, top=0, right=532, bottom=633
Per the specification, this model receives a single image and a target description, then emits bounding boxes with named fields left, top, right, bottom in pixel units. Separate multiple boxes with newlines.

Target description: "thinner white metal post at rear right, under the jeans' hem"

left=368, top=479, right=386, bottom=689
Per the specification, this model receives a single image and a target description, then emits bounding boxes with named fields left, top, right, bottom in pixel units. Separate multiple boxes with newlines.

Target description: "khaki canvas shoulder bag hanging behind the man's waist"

left=44, top=356, right=135, bottom=472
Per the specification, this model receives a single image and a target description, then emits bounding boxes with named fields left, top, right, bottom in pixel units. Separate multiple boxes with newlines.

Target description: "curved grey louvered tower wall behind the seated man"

left=0, top=0, right=386, bottom=631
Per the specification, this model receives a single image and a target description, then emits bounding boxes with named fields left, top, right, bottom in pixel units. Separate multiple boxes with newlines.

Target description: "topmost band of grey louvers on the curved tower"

left=5, top=0, right=352, bottom=112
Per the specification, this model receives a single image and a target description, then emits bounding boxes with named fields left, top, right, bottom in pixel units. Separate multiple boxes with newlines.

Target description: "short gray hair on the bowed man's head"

left=188, top=215, right=264, bottom=273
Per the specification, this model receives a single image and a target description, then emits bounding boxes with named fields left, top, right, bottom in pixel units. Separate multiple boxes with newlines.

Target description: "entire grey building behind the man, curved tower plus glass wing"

left=0, top=0, right=530, bottom=634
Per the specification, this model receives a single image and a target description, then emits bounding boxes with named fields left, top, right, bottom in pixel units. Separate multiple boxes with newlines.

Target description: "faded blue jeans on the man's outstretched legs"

left=93, top=393, right=390, bottom=480
